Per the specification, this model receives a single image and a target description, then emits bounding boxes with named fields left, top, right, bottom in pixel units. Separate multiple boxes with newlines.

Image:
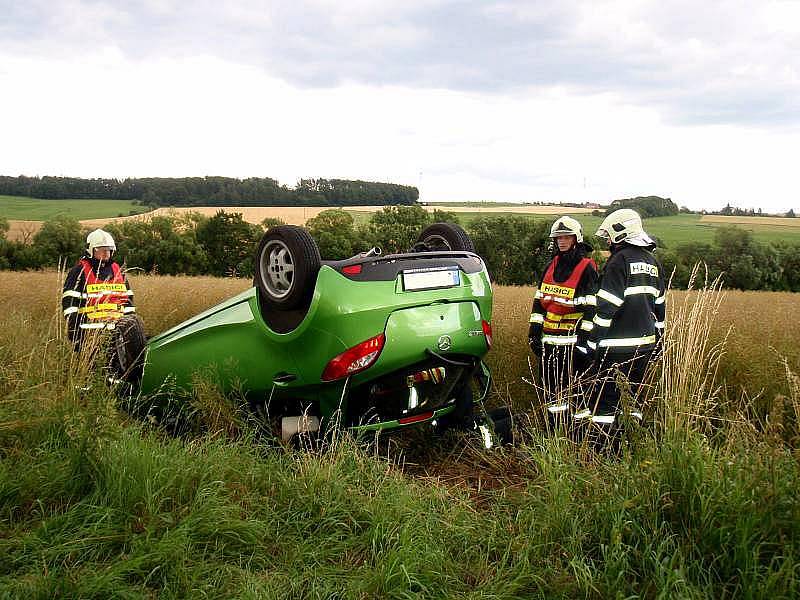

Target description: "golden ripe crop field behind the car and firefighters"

left=0, top=271, right=800, bottom=409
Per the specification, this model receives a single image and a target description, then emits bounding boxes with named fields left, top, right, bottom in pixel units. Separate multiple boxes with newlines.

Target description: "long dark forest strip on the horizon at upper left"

left=0, top=175, right=419, bottom=207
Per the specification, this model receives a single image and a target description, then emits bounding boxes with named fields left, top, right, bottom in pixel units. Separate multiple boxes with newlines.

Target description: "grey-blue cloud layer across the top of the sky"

left=0, top=0, right=800, bottom=127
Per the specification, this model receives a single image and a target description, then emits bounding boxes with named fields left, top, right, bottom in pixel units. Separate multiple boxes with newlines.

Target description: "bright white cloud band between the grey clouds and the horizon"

left=0, top=47, right=800, bottom=210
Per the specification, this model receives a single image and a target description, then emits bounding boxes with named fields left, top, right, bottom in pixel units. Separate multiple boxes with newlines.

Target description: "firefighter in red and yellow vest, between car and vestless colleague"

left=528, top=216, right=598, bottom=422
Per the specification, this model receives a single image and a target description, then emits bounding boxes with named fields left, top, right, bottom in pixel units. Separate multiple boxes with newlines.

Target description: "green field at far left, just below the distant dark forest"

left=0, top=196, right=149, bottom=221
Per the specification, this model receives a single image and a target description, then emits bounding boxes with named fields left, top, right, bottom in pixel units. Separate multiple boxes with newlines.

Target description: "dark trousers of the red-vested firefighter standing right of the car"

left=539, top=344, right=589, bottom=426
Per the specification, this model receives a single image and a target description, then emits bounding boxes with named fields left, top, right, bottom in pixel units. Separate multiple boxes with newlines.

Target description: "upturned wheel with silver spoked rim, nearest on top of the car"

left=254, top=225, right=321, bottom=310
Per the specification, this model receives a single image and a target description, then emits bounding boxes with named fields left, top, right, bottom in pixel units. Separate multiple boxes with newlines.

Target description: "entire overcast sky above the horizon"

left=0, top=0, right=800, bottom=211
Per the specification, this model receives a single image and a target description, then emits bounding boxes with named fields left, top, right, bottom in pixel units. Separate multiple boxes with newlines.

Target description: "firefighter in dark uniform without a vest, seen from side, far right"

left=575, top=209, right=666, bottom=444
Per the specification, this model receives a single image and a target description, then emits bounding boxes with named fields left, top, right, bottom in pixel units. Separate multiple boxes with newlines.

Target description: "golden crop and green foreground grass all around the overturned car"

left=0, top=272, right=800, bottom=599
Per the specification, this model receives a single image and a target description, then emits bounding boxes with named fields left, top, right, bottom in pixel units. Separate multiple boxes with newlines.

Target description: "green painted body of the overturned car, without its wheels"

left=140, top=252, right=492, bottom=430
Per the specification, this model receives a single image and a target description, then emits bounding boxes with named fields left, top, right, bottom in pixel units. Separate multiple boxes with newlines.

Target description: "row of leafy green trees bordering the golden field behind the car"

left=0, top=210, right=800, bottom=292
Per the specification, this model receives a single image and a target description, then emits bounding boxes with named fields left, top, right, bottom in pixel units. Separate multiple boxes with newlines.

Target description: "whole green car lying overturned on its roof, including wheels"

left=115, top=223, right=492, bottom=439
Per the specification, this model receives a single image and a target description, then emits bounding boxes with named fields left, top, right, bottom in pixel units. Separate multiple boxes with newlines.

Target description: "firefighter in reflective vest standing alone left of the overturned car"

left=61, top=229, right=136, bottom=349
